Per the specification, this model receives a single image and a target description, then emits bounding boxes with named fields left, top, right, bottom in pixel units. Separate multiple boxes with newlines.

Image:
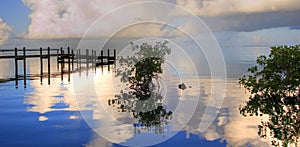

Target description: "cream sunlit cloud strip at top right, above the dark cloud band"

left=176, top=0, right=300, bottom=16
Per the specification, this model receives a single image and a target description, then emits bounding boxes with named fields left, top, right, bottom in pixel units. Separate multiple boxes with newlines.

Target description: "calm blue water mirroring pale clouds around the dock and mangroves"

left=0, top=40, right=270, bottom=146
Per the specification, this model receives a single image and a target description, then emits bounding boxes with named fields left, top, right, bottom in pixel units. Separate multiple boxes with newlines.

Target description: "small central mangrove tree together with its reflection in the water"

left=109, top=41, right=172, bottom=130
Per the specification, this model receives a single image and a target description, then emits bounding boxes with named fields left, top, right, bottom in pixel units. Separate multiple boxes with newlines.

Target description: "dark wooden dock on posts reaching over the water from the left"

left=0, top=47, right=116, bottom=87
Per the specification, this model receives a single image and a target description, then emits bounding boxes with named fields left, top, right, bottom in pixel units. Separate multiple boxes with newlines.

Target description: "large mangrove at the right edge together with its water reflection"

left=240, top=45, right=300, bottom=146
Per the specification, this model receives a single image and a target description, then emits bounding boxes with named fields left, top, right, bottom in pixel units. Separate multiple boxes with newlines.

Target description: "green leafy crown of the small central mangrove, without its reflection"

left=116, top=41, right=171, bottom=83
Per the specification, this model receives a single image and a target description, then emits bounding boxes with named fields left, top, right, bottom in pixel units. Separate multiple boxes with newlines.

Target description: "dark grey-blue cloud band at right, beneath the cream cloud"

left=203, top=10, right=300, bottom=32
